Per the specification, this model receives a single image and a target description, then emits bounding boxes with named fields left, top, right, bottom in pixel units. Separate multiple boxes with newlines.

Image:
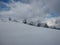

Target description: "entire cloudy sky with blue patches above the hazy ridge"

left=0, top=0, right=60, bottom=27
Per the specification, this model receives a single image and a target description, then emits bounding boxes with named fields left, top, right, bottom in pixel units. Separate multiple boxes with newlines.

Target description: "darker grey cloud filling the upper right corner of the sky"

left=44, top=0, right=60, bottom=13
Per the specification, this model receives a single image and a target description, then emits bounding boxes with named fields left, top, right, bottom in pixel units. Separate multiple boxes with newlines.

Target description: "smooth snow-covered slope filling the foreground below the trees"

left=0, top=21, right=60, bottom=45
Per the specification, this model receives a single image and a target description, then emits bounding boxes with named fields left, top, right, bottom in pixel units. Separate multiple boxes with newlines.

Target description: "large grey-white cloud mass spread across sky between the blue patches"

left=0, top=0, right=60, bottom=28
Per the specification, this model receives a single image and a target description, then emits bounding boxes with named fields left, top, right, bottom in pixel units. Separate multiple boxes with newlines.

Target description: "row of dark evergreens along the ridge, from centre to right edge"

left=23, top=19, right=60, bottom=30
